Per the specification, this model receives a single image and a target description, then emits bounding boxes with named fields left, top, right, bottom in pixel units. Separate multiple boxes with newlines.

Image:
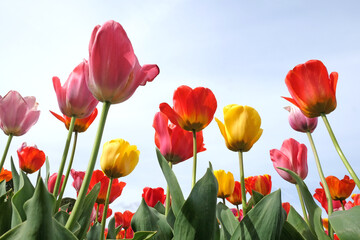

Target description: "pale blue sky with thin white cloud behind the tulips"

left=0, top=0, right=360, bottom=216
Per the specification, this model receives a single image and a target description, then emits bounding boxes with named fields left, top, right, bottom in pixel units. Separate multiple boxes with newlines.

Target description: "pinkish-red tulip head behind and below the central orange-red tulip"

left=153, top=112, right=206, bottom=164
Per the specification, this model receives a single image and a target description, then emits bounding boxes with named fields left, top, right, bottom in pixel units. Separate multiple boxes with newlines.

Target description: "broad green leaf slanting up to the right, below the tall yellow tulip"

left=231, top=190, right=285, bottom=240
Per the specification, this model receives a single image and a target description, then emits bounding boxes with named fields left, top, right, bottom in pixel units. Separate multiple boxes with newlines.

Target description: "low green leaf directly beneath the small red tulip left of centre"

left=131, top=199, right=173, bottom=240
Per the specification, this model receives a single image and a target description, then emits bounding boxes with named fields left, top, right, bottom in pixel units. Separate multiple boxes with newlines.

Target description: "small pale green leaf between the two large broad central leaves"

left=216, top=203, right=240, bottom=239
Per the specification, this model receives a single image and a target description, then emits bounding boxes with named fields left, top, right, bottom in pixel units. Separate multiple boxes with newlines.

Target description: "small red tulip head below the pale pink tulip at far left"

left=17, top=142, right=46, bottom=173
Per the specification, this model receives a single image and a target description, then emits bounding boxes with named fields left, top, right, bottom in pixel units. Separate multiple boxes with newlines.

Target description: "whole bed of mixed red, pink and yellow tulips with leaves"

left=0, top=15, right=360, bottom=240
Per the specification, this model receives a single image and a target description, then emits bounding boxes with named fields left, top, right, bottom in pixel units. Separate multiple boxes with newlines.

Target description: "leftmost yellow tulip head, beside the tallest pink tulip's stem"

left=100, top=138, right=140, bottom=178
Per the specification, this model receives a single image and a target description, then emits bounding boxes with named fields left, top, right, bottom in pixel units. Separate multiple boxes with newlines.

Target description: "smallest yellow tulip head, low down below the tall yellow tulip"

left=214, top=170, right=235, bottom=199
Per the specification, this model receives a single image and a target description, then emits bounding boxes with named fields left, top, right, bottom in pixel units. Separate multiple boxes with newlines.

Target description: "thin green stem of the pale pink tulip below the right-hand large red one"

left=306, top=132, right=333, bottom=239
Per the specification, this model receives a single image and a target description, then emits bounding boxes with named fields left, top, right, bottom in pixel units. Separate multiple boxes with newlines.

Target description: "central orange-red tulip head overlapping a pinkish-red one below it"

left=160, top=85, right=217, bottom=132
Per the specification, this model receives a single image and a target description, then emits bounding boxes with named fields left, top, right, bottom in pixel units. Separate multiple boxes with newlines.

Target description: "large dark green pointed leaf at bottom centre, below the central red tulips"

left=174, top=168, right=218, bottom=240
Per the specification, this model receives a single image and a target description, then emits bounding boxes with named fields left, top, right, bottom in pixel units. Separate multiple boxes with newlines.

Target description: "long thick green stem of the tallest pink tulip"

left=65, top=102, right=111, bottom=229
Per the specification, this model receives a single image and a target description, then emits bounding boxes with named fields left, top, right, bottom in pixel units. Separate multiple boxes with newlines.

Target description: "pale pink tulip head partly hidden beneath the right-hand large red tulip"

left=285, top=106, right=318, bottom=133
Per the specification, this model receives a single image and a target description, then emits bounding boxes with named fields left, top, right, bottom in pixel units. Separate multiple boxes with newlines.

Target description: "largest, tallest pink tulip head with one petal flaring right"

left=88, top=21, right=159, bottom=103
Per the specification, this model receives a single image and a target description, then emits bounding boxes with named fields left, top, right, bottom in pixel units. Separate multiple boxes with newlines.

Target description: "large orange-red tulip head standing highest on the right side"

left=284, top=60, right=338, bottom=118
